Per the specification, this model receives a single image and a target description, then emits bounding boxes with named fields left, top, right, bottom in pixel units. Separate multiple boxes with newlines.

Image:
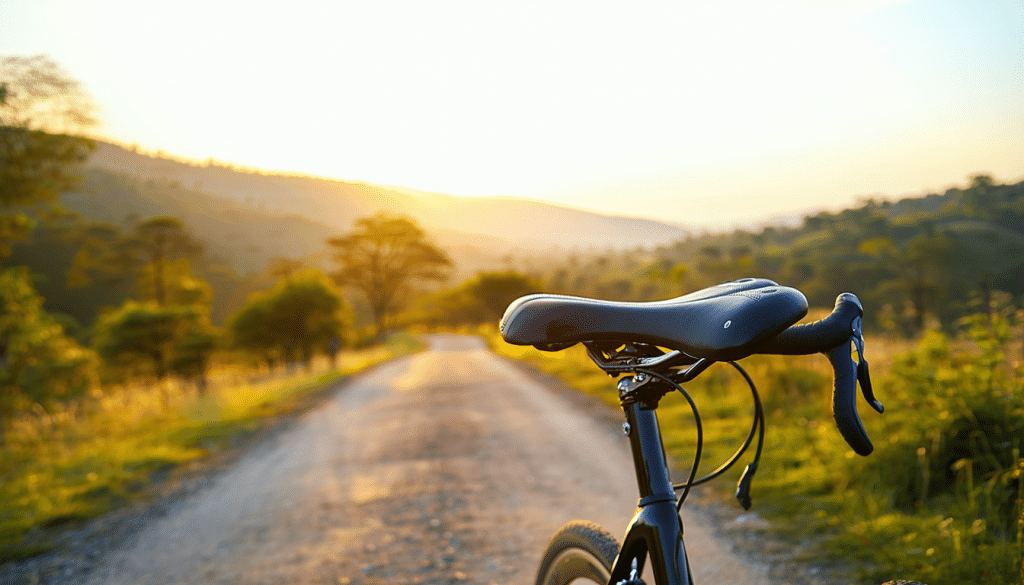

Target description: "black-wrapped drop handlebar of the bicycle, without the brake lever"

left=757, top=293, right=874, bottom=455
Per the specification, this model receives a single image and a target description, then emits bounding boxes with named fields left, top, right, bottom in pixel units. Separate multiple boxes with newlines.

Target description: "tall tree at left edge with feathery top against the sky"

left=0, top=55, right=95, bottom=260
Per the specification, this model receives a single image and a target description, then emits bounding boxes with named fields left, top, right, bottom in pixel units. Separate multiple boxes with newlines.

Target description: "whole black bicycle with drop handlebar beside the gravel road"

left=500, top=279, right=917, bottom=585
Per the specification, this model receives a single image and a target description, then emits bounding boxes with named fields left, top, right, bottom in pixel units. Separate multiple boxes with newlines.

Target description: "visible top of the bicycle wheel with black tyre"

left=537, top=520, right=618, bottom=585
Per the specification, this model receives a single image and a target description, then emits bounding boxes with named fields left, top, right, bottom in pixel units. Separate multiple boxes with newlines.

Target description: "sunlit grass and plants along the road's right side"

left=480, top=327, right=1024, bottom=585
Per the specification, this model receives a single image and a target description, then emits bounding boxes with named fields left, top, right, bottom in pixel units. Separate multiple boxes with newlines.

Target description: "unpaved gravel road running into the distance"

left=75, top=335, right=767, bottom=585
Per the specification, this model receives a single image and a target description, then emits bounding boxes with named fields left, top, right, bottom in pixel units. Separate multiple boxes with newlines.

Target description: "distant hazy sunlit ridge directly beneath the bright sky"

left=88, top=142, right=687, bottom=257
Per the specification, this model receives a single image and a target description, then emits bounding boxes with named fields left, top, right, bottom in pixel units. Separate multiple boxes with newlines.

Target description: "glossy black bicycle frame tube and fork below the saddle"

left=609, top=397, right=692, bottom=585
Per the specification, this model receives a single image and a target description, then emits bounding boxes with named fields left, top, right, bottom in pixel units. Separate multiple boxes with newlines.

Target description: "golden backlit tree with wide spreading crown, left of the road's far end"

left=328, top=213, right=452, bottom=340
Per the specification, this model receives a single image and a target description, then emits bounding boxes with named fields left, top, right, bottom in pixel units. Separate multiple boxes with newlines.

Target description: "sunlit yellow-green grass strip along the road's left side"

left=0, top=335, right=422, bottom=563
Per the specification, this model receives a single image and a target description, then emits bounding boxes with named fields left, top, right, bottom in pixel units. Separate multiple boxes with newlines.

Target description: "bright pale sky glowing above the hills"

left=0, top=0, right=1024, bottom=228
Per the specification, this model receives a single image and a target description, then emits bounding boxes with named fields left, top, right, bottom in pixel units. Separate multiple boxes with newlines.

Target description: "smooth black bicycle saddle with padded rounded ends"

left=501, top=279, right=807, bottom=362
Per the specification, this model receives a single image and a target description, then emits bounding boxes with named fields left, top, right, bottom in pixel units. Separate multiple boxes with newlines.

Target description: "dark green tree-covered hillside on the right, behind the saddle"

left=528, top=175, right=1024, bottom=336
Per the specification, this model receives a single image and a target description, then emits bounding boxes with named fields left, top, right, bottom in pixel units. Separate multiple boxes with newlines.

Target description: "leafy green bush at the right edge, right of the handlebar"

left=851, top=315, right=1024, bottom=583
